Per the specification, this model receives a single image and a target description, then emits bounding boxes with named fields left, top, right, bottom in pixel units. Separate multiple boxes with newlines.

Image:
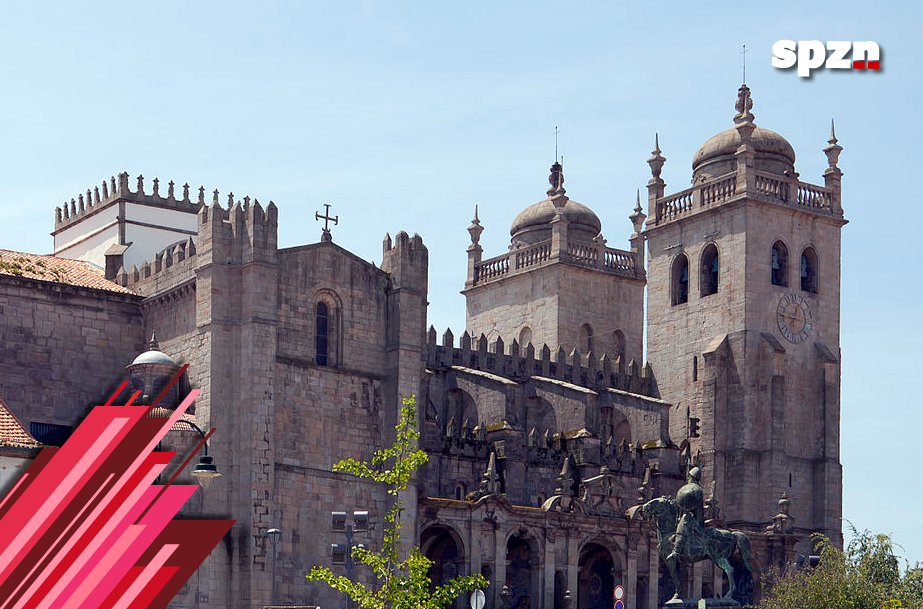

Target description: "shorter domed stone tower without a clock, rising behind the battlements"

left=462, top=163, right=645, bottom=371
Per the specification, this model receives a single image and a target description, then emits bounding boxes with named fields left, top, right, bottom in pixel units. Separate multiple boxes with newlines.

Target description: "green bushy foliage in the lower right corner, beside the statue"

left=759, top=525, right=923, bottom=609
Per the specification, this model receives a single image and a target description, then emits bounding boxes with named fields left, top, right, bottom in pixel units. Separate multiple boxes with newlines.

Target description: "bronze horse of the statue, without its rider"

left=641, top=497, right=753, bottom=601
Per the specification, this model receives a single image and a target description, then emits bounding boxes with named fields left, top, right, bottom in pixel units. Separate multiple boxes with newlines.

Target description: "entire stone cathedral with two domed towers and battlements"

left=0, top=85, right=846, bottom=609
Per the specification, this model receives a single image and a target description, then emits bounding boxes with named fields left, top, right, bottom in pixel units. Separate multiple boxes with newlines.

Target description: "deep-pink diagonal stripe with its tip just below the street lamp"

left=77, top=484, right=198, bottom=609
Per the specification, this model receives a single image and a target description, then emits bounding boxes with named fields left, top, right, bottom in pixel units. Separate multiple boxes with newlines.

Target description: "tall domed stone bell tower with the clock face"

left=644, top=85, right=846, bottom=540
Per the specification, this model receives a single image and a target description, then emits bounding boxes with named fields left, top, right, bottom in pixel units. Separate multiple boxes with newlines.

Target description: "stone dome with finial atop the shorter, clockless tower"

left=510, top=162, right=602, bottom=245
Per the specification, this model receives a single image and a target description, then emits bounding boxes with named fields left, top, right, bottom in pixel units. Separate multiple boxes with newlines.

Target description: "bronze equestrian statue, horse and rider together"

left=641, top=467, right=753, bottom=602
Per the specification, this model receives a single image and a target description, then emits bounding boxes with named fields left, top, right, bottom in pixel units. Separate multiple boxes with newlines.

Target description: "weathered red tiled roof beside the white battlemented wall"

left=0, top=249, right=134, bottom=294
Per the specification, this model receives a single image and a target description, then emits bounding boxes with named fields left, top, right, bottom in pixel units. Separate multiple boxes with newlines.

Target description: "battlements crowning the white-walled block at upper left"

left=54, top=171, right=202, bottom=232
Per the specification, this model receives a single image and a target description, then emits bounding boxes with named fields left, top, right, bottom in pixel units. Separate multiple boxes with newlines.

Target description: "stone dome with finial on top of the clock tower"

left=692, top=85, right=795, bottom=183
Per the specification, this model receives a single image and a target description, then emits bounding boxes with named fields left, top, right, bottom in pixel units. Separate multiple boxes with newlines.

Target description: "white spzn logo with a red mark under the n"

left=772, top=40, right=881, bottom=77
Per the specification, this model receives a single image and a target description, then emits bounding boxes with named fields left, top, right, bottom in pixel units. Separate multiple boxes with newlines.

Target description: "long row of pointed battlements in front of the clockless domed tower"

left=426, top=326, right=654, bottom=397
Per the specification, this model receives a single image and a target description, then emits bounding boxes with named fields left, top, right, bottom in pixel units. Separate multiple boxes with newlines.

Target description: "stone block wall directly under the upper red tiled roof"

left=0, top=275, right=146, bottom=430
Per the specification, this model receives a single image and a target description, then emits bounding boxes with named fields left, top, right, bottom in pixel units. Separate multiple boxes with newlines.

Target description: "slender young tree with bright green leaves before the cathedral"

left=307, top=397, right=488, bottom=609
